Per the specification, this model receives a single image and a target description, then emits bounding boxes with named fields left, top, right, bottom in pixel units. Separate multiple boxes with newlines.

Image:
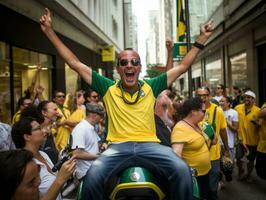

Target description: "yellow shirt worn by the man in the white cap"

left=235, top=104, right=260, bottom=146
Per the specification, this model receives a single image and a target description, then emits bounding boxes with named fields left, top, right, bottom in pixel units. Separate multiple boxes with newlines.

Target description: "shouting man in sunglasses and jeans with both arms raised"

left=40, top=8, right=213, bottom=200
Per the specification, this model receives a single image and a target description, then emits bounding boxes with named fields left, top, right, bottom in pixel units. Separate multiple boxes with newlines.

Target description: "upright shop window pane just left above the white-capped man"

left=230, top=52, right=247, bottom=88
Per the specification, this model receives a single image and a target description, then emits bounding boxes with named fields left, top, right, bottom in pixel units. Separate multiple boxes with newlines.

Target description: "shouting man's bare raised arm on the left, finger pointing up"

left=40, top=8, right=92, bottom=84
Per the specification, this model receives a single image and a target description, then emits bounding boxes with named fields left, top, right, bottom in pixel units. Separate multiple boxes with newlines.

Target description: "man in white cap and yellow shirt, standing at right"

left=235, top=90, right=260, bottom=181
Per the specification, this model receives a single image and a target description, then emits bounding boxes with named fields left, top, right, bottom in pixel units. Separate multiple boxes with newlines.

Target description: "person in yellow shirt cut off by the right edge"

left=255, top=102, right=266, bottom=179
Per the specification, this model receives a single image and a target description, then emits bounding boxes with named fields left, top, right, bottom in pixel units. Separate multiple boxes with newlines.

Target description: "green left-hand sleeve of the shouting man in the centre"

left=91, top=71, right=115, bottom=97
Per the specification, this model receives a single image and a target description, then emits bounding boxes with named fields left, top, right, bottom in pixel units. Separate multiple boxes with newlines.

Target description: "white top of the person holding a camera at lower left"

left=34, top=151, right=62, bottom=200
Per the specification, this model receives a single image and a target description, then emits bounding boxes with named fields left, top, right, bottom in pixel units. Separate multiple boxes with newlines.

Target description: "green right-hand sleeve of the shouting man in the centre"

left=145, top=73, right=167, bottom=97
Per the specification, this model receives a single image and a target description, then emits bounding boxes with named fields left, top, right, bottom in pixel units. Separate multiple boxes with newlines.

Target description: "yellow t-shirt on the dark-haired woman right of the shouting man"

left=171, top=121, right=211, bottom=176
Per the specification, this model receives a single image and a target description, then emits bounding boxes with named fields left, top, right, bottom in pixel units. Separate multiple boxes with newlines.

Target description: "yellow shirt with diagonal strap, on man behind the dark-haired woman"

left=200, top=103, right=227, bottom=160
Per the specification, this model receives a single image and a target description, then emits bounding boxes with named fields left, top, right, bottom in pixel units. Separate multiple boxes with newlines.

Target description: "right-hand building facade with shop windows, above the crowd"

left=181, top=0, right=266, bottom=105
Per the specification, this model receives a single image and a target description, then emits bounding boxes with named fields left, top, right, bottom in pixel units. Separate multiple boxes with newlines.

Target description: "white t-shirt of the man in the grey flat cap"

left=71, top=119, right=100, bottom=179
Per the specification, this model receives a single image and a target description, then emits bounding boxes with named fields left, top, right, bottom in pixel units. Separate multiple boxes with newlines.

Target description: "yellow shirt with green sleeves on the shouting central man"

left=91, top=71, right=167, bottom=143
